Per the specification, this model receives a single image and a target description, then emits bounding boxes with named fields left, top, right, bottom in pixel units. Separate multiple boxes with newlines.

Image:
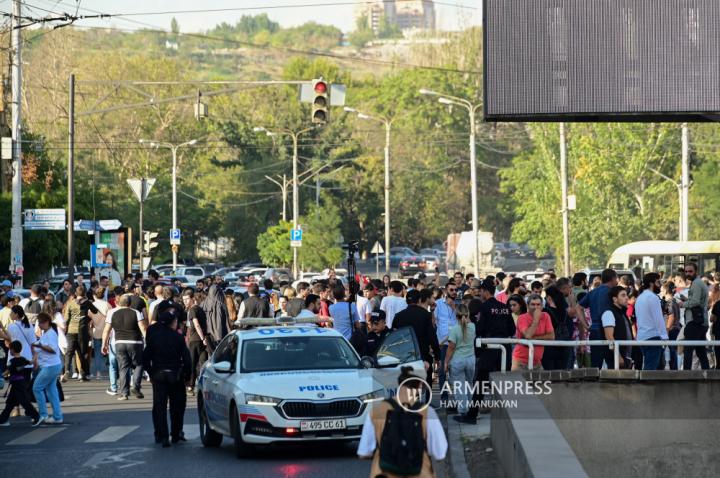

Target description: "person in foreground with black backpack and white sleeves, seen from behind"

left=357, top=367, right=448, bottom=478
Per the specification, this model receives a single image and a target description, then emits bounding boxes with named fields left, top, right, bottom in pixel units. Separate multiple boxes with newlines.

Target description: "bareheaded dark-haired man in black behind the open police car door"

left=393, top=289, right=440, bottom=383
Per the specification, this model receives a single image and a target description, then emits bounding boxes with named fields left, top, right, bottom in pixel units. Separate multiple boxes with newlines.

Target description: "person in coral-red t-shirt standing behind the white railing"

left=512, top=294, right=555, bottom=370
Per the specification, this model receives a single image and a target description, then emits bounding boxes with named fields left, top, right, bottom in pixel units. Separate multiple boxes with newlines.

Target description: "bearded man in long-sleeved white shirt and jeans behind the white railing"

left=635, top=272, right=668, bottom=370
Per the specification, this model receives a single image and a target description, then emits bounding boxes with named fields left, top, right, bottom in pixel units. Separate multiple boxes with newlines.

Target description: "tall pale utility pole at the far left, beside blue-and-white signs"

left=10, top=0, right=24, bottom=287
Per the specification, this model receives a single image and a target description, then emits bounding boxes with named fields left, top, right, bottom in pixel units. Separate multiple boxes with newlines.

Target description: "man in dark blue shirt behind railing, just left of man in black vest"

left=577, top=269, right=618, bottom=368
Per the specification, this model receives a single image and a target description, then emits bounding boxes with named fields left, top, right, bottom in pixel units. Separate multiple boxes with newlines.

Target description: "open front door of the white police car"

left=373, top=327, right=432, bottom=398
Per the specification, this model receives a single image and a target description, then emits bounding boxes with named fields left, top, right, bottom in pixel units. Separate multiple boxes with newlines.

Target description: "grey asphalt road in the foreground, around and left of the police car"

left=0, top=380, right=370, bottom=478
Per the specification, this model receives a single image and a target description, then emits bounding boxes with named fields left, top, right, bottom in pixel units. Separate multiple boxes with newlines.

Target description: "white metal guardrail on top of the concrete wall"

left=475, top=337, right=720, bottom=372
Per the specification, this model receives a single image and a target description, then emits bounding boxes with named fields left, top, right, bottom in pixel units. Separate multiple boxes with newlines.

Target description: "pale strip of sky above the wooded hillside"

left=8, top=0, right=482, bottom=32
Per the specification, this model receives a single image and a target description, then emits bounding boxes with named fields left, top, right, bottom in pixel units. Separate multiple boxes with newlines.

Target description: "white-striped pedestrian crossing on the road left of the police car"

left=0, top=423, right=200, bottom=446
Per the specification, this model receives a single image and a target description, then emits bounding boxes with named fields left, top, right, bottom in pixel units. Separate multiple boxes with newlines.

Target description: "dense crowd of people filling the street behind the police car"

left=0, top=263, right=720, bottom=432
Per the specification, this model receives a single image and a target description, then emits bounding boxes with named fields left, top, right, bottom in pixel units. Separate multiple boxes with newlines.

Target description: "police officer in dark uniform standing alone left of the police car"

left=143, top=303, right=191, bottom=448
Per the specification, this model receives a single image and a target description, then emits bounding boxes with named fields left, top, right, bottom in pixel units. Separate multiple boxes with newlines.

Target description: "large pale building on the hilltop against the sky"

left=362, top=0, right=435, bottom=34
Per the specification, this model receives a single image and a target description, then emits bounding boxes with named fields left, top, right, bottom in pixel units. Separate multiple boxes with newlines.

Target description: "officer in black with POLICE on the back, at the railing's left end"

left=453, top=279, right=515, bottom=424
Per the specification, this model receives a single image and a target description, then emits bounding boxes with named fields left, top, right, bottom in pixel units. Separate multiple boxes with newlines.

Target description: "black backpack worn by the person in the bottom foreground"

left=380, top=400, right=425, bottom=476
